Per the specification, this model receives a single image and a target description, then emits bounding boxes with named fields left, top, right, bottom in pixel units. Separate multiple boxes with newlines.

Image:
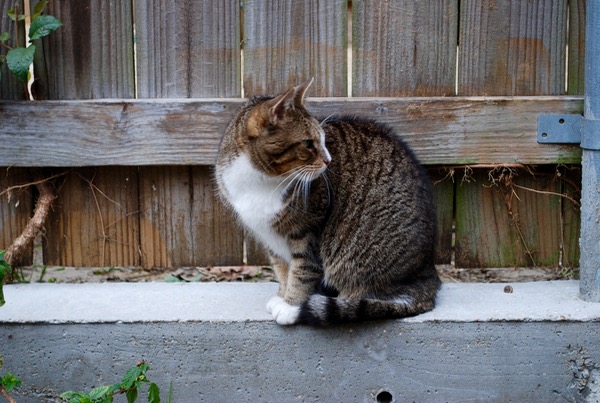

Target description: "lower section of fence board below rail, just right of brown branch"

left=44, top=167, right=140, bottom=267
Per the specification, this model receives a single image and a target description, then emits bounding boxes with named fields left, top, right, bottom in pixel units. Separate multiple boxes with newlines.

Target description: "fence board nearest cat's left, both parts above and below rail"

left=136, top=0, right=243, bottom=267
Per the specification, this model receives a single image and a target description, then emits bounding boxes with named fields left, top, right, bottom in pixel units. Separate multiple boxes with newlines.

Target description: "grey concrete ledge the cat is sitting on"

left=0, top=281, right=600, bottom=402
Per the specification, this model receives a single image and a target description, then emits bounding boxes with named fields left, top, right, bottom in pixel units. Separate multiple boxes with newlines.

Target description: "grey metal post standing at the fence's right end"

left=579, top=0, right=600, bottom=302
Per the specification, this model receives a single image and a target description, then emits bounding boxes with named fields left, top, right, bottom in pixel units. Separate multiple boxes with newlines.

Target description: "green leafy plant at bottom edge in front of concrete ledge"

left=60, top=361, right=160, bottom=403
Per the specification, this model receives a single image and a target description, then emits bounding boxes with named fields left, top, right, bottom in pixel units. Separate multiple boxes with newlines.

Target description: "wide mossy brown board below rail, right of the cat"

left=456, top=166, right=572, bottom=267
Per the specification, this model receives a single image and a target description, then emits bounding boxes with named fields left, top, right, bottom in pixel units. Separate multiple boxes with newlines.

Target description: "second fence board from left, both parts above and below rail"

left=34, top=0, right=139, bottom=266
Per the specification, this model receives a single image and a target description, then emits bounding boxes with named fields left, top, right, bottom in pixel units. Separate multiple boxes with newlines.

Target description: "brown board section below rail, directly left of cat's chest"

left=140, top=166, right=243, bottom=268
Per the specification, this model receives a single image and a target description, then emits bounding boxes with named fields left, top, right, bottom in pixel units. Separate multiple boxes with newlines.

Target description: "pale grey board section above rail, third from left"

left=135, top=0, right=241, bottom=98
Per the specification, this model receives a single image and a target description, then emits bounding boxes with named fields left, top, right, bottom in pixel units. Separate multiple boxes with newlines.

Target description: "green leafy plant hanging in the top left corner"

left=0, top=1, right=63, bottom=87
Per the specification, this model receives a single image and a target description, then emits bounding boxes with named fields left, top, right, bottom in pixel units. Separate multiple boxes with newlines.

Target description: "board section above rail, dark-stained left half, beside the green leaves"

left=34, top=0, right=135, bottom=99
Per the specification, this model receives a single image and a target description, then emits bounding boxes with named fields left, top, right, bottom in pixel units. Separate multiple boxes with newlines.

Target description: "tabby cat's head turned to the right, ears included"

left=239, top=81, right=331, bottom=180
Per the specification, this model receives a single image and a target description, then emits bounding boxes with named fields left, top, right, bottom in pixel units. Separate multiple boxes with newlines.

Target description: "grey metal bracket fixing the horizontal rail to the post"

left=537, top=114, right=600, bottom=150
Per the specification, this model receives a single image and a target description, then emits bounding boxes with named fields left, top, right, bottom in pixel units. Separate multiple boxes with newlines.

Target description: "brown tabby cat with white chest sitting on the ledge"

left=215, top=80, right=441, bottom=325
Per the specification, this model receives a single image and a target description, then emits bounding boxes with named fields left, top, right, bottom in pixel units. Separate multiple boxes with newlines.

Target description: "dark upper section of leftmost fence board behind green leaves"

left=0, top=0, right=25, bottom=99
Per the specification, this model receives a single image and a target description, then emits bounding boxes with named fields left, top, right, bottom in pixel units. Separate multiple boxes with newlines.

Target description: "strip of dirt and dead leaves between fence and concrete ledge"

left=16, top=265, right=575, bottom=283
